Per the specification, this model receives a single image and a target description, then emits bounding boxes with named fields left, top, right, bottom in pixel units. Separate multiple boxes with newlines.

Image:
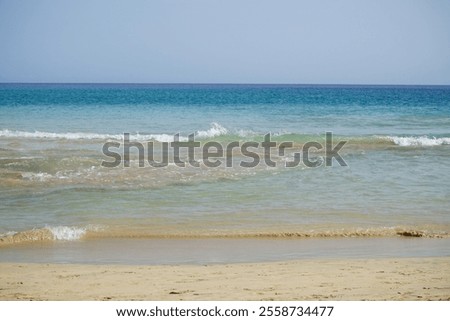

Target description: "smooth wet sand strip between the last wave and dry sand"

left=0, top=236, right=450, bottom=265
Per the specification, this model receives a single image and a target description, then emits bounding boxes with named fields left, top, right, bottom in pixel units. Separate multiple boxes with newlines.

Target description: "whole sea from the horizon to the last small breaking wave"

left=0, top=84, right=450, bottom=244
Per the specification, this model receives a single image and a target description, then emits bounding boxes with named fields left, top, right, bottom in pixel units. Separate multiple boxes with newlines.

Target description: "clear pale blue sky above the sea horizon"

left=0, top=0, right=450, bottom=85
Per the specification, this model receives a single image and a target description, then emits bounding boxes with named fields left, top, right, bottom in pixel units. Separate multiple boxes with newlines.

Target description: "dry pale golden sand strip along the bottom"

left=0, top=257, right=450, bottom=301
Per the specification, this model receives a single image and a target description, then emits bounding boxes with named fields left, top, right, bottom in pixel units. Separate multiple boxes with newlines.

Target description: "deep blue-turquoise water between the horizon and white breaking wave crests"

left=0, top=84, right=450, bottom=136
